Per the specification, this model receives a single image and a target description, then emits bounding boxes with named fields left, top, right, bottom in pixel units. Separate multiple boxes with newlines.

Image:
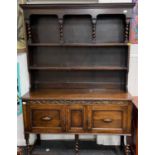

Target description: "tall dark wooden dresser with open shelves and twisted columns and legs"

left=21, top=3, right=134, bottom=155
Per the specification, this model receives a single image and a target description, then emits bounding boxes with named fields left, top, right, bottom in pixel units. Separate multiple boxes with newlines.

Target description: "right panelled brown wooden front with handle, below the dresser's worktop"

left=88, top=105, right=131, bottom=134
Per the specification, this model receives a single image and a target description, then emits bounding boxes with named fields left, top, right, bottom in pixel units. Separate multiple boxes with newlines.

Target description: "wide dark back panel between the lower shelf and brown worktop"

left=31, top=70, right=126, bottom=90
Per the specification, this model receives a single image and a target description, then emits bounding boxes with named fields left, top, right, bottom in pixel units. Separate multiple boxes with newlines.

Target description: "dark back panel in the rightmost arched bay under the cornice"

left=96, top=15, right=125, bottom=42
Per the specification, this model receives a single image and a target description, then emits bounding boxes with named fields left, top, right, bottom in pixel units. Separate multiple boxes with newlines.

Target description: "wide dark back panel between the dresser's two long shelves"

left=29, top=46, right=128, bottom=67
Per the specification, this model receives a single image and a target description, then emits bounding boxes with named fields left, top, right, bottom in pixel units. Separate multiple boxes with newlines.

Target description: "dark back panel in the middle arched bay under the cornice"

left=64, top=15, right=92, bottom=43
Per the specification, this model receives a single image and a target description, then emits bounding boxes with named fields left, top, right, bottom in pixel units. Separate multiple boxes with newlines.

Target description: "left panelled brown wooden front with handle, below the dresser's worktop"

left=27, top=104, right=65, bottom=133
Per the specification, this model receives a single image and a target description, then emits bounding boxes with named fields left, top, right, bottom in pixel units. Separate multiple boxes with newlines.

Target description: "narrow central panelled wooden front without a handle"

left=67, top=105, right=86, bottom=133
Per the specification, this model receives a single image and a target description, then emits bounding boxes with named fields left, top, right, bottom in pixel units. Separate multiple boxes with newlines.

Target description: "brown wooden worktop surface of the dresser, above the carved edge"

left=22, top=89, right=132, bottom=101
